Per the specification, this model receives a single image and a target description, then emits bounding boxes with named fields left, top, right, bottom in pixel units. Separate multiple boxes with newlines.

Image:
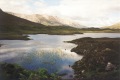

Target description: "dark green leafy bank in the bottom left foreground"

left=0, top=63, right=61, bottom=80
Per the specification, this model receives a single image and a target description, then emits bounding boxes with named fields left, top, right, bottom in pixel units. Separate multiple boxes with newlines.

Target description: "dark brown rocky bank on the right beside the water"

left=71, top=38, right=120, bottom=80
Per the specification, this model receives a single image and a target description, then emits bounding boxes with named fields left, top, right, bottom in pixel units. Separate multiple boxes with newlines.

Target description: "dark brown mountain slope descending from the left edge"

left=0, top=9, right=45, bottom=32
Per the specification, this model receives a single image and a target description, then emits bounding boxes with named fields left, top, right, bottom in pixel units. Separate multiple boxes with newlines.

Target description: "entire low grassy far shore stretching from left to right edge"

left=0, top=26, right=120, bottom=40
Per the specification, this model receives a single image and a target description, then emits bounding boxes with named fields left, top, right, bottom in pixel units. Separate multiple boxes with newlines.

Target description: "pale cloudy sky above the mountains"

left=0, top=0, right=120, bottom=27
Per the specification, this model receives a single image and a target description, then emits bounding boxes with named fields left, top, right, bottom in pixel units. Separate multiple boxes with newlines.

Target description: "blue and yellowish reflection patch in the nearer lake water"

left=21, top=48, right=80, bottom=72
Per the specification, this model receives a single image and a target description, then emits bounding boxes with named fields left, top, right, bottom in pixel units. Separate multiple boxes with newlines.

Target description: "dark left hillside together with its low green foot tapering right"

left=0, top=9, right=81, bottom=37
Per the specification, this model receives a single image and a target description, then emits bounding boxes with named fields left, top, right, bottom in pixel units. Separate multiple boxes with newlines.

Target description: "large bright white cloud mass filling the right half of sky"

left=54, top=0, right=120, bottom=27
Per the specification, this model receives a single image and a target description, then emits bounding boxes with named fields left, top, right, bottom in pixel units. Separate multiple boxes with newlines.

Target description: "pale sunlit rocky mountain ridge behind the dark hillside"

left=8, top=12, right=85, bottom=28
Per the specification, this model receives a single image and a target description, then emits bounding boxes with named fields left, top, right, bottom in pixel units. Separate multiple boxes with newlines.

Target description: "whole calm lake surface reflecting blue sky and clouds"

left=0, top=33, right=120, bottom=79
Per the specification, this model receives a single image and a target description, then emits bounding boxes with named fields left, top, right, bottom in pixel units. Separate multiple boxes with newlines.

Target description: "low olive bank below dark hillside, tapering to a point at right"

left=0, top=26, right=82, bottom=40
